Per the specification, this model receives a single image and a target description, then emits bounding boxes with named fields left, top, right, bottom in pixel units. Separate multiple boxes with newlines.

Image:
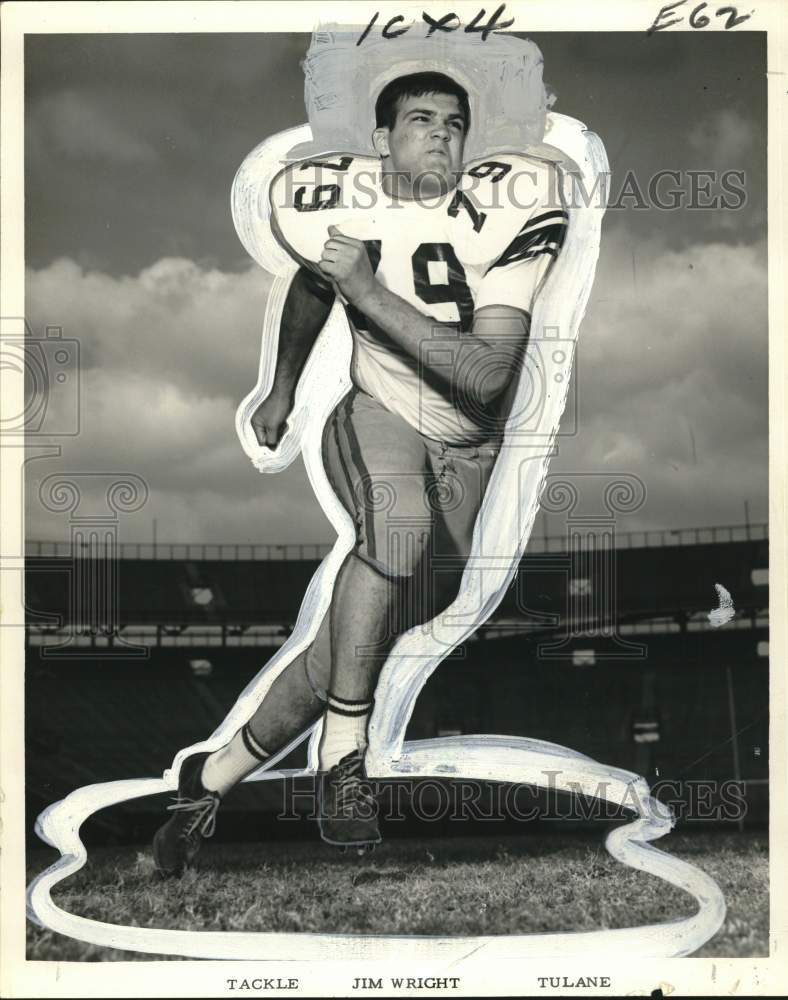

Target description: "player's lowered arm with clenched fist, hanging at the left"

left=252, top=267, right=334, bottom=448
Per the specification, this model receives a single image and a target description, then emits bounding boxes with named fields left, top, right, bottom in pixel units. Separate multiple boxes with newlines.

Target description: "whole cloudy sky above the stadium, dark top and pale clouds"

left=25, top=32, right=768, bottom=543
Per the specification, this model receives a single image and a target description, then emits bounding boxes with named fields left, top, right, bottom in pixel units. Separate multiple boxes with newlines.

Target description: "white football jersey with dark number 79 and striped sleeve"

left=270, top=153, right=568, bottom=443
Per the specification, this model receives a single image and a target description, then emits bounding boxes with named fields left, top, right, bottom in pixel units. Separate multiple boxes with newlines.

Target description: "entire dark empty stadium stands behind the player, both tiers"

left=26, top=537, right=769, bottom=841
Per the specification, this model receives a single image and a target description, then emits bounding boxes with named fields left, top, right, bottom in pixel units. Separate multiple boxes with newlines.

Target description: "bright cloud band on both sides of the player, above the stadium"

left=21, top=231, right=768, bottom=544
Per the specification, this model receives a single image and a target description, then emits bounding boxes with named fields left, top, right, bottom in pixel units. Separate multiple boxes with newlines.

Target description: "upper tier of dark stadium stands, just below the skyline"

left=21, top=540, right=768, bottom=627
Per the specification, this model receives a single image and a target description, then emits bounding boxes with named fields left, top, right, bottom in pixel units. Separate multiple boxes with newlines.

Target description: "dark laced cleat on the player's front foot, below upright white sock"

left=317, top=750, right=381, bottom=853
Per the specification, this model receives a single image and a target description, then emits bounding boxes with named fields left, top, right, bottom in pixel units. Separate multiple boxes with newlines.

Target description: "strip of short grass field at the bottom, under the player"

left=28, top=833, right=769, bottom=961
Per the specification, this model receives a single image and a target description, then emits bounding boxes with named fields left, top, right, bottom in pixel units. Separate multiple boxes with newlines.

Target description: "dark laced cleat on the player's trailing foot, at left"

left=153, top=753, right=221, bottom=875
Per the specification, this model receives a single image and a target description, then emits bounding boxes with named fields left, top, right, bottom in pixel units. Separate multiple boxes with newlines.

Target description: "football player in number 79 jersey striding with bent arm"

left=154, top=73, right=567, bottom=874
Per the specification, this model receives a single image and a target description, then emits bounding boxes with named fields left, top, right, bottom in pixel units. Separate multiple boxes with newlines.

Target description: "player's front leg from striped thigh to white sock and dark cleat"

left=320, top=392, right=430, bottom=844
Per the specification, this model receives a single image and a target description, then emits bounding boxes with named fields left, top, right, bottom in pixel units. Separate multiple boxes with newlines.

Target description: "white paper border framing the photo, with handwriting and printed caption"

left=0, top=0, right=788, bottom=997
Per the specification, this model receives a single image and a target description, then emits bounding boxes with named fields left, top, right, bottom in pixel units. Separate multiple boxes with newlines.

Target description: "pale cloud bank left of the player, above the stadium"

left=27, top=258, right=332, bottom=543
